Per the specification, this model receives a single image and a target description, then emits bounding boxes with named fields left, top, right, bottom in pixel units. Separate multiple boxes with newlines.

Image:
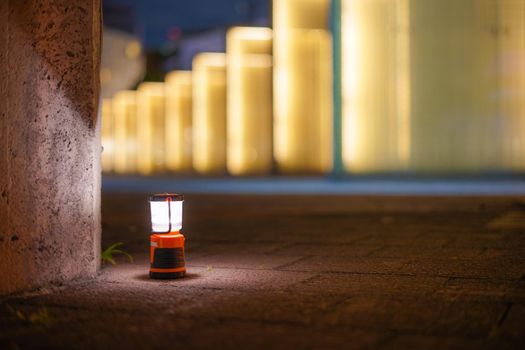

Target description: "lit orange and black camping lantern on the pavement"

left=149, top=193, right=186, bottom=279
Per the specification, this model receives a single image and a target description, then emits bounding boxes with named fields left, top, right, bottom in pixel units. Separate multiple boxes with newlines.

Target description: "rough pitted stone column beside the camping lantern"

left=0, top=0, right=101, bottom=294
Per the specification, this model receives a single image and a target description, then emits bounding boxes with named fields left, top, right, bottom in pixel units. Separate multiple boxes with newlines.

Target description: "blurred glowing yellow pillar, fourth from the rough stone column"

left=166, top=71, right=192, bottom=171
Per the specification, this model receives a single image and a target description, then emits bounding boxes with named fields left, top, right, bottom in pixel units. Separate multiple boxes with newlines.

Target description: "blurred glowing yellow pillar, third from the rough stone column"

left=137, top=82, right=166, bottom=175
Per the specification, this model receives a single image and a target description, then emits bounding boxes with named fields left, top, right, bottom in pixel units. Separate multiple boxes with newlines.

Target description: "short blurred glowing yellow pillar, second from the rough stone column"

left=112, top=91, right=138, bottom=174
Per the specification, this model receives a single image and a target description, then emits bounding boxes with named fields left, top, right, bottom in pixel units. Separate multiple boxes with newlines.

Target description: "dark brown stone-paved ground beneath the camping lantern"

left=0, top=193, right=525, bottom=349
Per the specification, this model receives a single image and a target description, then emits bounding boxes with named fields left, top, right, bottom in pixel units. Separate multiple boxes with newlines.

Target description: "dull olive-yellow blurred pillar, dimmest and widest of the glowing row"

left=410, top=0, right=501, bottom=172
